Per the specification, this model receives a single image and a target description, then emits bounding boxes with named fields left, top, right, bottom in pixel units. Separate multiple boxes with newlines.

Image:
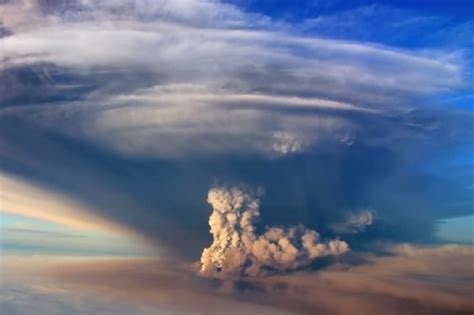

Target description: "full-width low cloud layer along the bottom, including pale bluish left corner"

left=0, top=245, right=474, bottom=315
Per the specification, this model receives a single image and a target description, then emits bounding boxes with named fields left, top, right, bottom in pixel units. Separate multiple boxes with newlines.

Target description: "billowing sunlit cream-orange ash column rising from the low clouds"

left=201, top=187, right=349, bottom=276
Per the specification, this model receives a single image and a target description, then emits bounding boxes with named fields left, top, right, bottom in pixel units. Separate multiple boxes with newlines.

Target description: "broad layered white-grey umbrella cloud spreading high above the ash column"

left=0, top=0, right=463, bottom=157
